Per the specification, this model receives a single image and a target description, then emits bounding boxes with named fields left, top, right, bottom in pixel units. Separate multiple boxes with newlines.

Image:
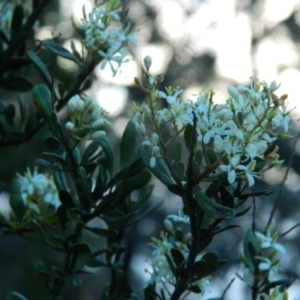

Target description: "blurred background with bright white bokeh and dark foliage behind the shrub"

left=0, top=0, right=300, bottom=299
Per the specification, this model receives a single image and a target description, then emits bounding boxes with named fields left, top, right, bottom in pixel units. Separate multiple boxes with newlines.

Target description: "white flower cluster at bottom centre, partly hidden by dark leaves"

left=146, top=210, right=210, bottom=295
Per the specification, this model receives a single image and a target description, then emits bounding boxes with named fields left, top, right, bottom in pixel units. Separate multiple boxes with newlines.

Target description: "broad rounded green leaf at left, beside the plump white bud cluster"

left=31, top=84, right=53, bottom=122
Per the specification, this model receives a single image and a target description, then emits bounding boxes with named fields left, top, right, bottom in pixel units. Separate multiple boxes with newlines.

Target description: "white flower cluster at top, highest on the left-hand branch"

left=83, top=6, right=137, bottom=75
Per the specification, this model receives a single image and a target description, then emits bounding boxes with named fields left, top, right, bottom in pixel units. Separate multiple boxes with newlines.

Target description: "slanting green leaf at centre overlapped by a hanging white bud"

left=139, top=144, right=175, bottom=186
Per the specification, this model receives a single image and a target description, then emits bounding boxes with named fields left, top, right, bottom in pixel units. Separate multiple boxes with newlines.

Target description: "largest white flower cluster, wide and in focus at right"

left=132, top=60, right=291, bottom=186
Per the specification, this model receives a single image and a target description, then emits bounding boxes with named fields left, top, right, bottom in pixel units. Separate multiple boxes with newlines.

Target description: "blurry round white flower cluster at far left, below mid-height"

left=17, top=169, right=61, bottom=213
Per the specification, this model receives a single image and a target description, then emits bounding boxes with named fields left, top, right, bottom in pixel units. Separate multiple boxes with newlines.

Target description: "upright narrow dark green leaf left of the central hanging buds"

left=120, top=121, right=138, bottom=168
